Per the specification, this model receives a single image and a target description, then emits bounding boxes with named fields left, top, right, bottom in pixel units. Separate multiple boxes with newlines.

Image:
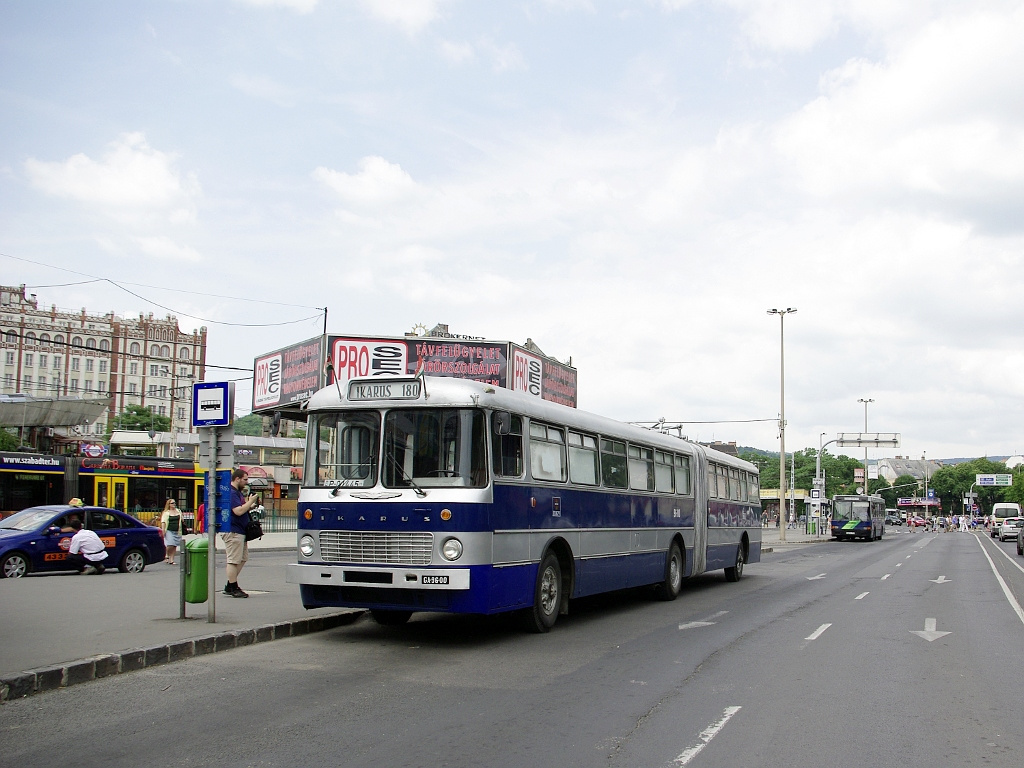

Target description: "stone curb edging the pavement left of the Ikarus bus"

left=0, top=610, right=365, bottom=702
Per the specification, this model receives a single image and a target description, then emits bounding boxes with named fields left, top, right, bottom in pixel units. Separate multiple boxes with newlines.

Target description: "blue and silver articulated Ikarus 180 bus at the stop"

left=287, top=377, right=761, bottom=632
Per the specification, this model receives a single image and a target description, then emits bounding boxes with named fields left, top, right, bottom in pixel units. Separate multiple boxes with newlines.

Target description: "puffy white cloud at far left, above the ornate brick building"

left=25, top=133, right=201, bottom=221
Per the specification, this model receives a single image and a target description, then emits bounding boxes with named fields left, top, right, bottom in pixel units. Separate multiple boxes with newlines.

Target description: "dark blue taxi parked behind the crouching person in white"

left=0, top=504, right=166, bottom=579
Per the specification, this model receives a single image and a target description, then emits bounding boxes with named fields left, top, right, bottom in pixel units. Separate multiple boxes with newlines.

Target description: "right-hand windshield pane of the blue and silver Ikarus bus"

left=382, top=409, right=487, bottom=488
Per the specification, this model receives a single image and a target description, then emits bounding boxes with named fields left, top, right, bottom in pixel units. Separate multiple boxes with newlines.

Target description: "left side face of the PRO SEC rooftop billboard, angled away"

left=253, top=336, right=324, bottom=411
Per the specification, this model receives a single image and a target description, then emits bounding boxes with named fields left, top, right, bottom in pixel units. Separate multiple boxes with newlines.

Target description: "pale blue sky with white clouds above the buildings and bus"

left=0, top=0, right=1024, bottom=458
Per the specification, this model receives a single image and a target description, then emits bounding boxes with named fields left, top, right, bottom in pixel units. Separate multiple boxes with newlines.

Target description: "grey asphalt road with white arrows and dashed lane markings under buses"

left=0, top=530, right=1024, bottom=768
